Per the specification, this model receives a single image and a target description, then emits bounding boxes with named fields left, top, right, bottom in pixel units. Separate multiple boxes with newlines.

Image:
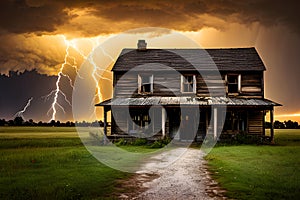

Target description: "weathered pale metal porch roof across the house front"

left=96, top=96, right=281, bottom=106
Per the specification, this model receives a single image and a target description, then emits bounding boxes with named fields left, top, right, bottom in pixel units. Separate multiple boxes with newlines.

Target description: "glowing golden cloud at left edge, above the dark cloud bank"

left=0, top=34, right=65, bottom=74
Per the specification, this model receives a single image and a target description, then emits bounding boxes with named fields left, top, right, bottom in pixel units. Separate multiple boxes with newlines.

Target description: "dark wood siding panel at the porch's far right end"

left=248, top=110, right=264, bottom=134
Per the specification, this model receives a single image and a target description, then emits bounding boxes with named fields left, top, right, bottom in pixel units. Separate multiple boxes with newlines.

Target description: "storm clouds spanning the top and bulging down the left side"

left=0, top=0, right=300, bottom=74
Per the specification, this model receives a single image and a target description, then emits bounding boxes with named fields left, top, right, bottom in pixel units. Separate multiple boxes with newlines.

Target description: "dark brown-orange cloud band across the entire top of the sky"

left=0, top=0, right=300, bottom=36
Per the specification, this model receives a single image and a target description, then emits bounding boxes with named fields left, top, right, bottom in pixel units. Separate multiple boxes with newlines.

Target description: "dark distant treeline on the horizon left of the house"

left=0, top=117, right=104, bottom=127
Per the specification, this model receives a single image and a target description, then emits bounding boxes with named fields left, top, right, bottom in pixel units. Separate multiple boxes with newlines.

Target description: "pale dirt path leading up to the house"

left=121, top=148, right=226, bottom=200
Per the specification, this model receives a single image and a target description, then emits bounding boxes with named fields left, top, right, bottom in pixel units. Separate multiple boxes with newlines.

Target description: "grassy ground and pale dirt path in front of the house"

left=0, top=127, right=300, bottom=200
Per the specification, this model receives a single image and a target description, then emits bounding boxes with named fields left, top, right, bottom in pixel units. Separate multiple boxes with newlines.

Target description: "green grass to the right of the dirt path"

left=206, top=130, right=300, bottom=199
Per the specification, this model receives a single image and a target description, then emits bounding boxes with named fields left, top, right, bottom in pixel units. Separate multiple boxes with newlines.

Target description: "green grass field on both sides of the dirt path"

left=0, top=127, right=300, bottom=199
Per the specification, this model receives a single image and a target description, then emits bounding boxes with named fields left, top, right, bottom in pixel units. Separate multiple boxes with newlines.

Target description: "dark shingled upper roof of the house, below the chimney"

left=112, top=47, right=265, bottom=71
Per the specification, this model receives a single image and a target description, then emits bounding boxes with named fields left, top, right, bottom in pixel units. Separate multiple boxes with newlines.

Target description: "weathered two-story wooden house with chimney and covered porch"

left=97, top=40, right=279, bottom=140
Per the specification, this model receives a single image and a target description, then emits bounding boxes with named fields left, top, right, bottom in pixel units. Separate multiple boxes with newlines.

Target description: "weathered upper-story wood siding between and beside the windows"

left=114, top=72, right=264, bottom=98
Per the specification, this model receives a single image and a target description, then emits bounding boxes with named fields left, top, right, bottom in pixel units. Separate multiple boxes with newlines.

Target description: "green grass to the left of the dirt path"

left=0, top=127, right=142, bottom=199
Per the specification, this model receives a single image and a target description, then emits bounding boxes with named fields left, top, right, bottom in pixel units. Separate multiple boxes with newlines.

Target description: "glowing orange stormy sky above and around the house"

left=0, top=0, right=300, bottom=122
